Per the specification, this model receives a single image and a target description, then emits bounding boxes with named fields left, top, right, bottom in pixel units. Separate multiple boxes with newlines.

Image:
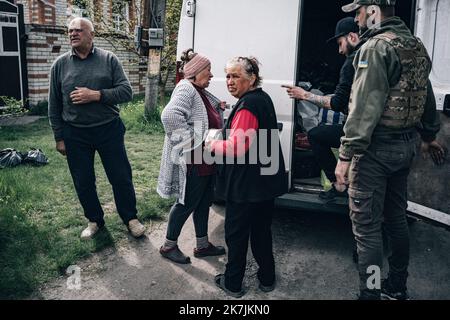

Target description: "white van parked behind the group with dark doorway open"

left=177, top=0, right=450, bottom=226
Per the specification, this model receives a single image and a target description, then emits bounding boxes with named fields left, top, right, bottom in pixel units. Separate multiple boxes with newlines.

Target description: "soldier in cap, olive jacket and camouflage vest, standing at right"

left=335, top=0, right=444, bottom=299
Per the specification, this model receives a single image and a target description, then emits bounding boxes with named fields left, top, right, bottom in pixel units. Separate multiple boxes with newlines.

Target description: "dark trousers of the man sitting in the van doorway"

left=308, top=124, right=344, bottom=182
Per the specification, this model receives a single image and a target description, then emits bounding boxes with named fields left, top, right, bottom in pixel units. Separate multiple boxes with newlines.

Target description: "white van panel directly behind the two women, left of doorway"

left=178, top=0, right=301, bottom=185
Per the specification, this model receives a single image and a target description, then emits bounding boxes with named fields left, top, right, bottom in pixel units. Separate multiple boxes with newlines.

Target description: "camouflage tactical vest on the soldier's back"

left=373, top=32, right=431, bottom=129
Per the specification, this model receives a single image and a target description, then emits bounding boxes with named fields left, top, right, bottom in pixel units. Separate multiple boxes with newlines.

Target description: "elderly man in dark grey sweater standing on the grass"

left=48, top=18, right=145, bottom=239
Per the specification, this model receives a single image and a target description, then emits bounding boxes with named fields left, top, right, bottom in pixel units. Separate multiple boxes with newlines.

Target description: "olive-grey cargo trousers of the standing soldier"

left=348, top=133, right=416, bottom=294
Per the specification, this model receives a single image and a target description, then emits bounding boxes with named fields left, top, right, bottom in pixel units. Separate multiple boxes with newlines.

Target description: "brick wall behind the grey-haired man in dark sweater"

left=16, top=0, right=147, bottom=105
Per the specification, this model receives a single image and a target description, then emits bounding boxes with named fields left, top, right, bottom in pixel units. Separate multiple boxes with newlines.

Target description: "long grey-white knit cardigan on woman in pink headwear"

left=157, top=80, right=223, bottom=204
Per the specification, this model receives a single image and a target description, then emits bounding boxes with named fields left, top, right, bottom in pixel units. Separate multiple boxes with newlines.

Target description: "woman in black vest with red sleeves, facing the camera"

left=206, top=57, right=288, bottom=297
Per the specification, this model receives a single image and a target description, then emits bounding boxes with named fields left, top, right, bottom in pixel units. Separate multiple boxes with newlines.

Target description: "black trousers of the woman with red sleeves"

left=225, top=199, right=275, bottom=291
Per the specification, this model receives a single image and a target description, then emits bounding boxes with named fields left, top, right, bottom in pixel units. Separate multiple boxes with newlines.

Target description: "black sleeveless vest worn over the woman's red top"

left=216, top=88, right=288, bottom=203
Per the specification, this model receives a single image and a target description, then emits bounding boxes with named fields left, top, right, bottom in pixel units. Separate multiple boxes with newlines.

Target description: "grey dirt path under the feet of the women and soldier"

left=34, top=206, right=450, bottom=300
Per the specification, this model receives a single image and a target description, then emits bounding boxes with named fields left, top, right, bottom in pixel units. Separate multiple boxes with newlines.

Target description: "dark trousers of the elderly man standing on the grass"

left=64, top=118, right=137, bottom=226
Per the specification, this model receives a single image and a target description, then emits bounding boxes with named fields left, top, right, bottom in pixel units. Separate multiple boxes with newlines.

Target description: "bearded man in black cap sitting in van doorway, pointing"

left=286, top=17, right=360, bottom=200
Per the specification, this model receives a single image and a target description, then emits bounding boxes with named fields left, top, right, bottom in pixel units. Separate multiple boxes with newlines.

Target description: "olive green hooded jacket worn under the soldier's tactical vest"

left=339, top=17, right=440, bottom=159
